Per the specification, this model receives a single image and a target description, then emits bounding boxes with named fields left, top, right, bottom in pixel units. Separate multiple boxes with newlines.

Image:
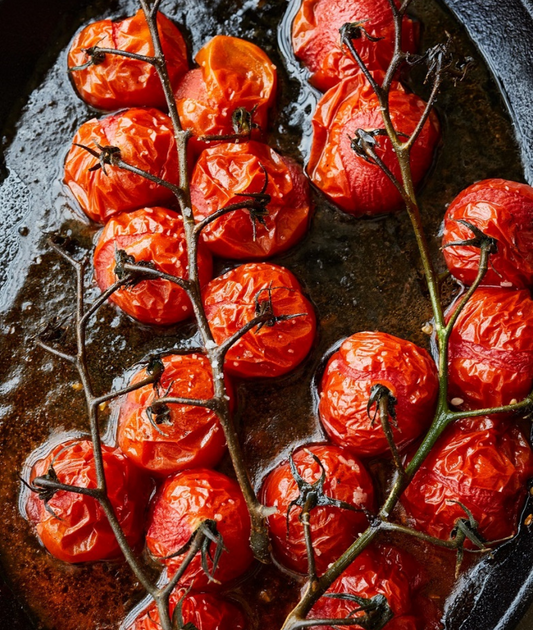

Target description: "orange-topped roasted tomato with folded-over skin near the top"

left=176, top=35, right=277, bottom=151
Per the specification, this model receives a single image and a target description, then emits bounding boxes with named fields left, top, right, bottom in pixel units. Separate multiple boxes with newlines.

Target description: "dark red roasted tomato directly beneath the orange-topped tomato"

left=191, top=142, right=311, bottom=259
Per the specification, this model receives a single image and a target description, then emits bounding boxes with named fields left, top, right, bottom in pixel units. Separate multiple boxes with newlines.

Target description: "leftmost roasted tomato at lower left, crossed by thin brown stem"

left=26, top=440, right=152, bottom=562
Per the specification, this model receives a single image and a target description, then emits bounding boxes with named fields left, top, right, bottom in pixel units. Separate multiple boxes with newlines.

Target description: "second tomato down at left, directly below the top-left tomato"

left=64, top=109, right=178, bottom=223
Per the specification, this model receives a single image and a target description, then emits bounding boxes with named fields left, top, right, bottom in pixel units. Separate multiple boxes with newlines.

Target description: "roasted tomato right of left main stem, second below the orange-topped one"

left=203, top=263, right=316, bottom=378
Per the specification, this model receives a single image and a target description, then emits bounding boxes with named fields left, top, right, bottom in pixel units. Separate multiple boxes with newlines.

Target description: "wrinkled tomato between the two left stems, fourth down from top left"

left=118, top=354, right=234, bottom=476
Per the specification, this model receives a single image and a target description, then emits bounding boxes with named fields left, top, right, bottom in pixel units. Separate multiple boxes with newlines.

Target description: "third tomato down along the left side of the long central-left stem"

left=94, top=208, right=212, bottom=325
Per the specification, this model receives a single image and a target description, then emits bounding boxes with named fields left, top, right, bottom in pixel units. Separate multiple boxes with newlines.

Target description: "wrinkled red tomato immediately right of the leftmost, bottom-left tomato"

left=146, top=468, right=253, bottom=589
